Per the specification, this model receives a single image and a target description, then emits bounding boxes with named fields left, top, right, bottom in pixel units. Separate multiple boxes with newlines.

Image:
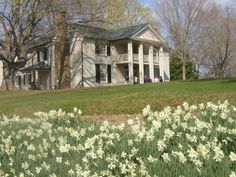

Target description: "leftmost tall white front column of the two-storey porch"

left=128, top=41, right=134, bottom=84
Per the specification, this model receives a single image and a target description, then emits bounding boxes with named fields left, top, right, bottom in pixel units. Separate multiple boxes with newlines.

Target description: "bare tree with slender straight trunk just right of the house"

left=157, top=0, right=207, bottom=80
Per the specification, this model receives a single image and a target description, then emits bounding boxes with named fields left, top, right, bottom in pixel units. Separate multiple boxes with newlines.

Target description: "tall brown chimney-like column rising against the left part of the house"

left=54, top=9, right=70, bottom=89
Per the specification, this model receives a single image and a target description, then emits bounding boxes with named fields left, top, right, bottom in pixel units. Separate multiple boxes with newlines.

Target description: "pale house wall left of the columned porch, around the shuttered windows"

left=70, top=38, right=126, bottom=88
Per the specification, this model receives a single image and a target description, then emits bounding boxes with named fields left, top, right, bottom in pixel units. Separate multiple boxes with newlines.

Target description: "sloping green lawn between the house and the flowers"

left=0, top=79, right=236, bottom=116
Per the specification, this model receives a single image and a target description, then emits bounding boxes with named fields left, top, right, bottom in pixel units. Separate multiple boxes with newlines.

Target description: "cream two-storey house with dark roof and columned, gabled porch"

left=0, top=24, right=170, bottom=90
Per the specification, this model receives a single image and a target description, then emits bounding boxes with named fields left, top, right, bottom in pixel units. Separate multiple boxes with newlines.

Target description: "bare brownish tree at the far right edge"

left=196, top=4, right=236, bottom=78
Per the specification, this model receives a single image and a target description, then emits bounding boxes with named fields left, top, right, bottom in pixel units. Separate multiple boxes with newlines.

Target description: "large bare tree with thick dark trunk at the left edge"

left=0, top=0, right=51, bottom=90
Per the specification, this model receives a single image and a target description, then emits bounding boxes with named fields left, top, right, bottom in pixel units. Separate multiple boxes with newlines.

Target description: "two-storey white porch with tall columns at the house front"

left=114, top=40, right=170, bottom=84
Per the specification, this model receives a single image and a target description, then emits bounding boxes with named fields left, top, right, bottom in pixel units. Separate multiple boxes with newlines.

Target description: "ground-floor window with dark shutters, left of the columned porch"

left=95, top=64, right=111, bottom=83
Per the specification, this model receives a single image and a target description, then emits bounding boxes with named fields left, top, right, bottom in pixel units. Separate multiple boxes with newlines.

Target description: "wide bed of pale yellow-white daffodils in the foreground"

left=0, top=101, right=236, bottom=177
